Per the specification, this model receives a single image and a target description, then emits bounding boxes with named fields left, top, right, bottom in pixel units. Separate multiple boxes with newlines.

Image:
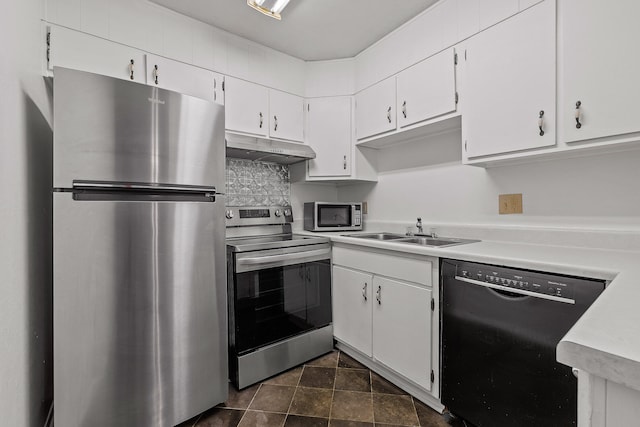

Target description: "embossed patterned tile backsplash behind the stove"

left=226, top=159, right=291, bottom=206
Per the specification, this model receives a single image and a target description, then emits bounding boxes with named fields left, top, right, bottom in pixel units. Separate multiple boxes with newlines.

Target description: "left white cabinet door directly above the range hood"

left=225, top=76, right=269, bottom=136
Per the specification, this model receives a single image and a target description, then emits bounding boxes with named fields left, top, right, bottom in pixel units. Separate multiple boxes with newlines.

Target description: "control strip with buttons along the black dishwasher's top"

left=457, top=263, right=573, bottom=299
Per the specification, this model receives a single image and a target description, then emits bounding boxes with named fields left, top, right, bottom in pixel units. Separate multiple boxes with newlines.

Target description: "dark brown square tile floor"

left=179, top=350, right=456, bottom=427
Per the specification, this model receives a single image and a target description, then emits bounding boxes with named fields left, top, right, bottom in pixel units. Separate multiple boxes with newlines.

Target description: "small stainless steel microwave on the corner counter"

left=304, top=202, right=362, bottom=231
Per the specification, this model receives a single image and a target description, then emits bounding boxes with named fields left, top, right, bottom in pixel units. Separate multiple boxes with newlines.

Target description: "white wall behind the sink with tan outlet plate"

left=338, top=131, right=640, bottom=230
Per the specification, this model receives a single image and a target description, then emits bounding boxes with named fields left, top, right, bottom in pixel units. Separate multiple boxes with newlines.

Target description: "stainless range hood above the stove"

left=225, top=132, right=316, bottom=165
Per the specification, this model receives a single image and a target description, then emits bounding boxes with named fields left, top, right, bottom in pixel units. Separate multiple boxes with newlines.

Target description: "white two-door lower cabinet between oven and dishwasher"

left=332, top=244, right=440, bottom=403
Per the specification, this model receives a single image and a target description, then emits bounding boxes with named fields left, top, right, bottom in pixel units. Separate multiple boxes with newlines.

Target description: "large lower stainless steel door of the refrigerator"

left=54, top=193, right=228, bottom=427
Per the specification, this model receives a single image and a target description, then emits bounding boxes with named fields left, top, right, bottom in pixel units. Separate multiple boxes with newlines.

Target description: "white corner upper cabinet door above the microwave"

left=307, top=96, right=351, bottom=176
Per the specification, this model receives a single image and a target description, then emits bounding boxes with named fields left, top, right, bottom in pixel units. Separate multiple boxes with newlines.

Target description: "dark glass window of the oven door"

left=234, top=259, right=331, bottom=355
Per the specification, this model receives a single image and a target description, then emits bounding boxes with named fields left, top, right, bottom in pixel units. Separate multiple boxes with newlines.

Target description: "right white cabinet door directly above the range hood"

left=269, top=89, right=304, bottom=142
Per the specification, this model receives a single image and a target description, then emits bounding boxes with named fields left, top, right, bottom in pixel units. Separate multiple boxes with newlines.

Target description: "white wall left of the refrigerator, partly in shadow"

left=0, top=0, right=53, bottom=427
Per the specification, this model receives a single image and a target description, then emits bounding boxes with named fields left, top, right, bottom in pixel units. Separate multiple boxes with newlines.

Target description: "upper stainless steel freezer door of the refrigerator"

left=53, top=67, right=225, bottom=191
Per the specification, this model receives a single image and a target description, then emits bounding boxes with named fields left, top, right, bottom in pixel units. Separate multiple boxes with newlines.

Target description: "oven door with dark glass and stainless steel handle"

left=229, top=244, right=331, bottom=356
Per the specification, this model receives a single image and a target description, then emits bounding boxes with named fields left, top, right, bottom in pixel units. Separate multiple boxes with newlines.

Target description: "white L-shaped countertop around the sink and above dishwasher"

left=298, top=231, right=640, bottom=390
